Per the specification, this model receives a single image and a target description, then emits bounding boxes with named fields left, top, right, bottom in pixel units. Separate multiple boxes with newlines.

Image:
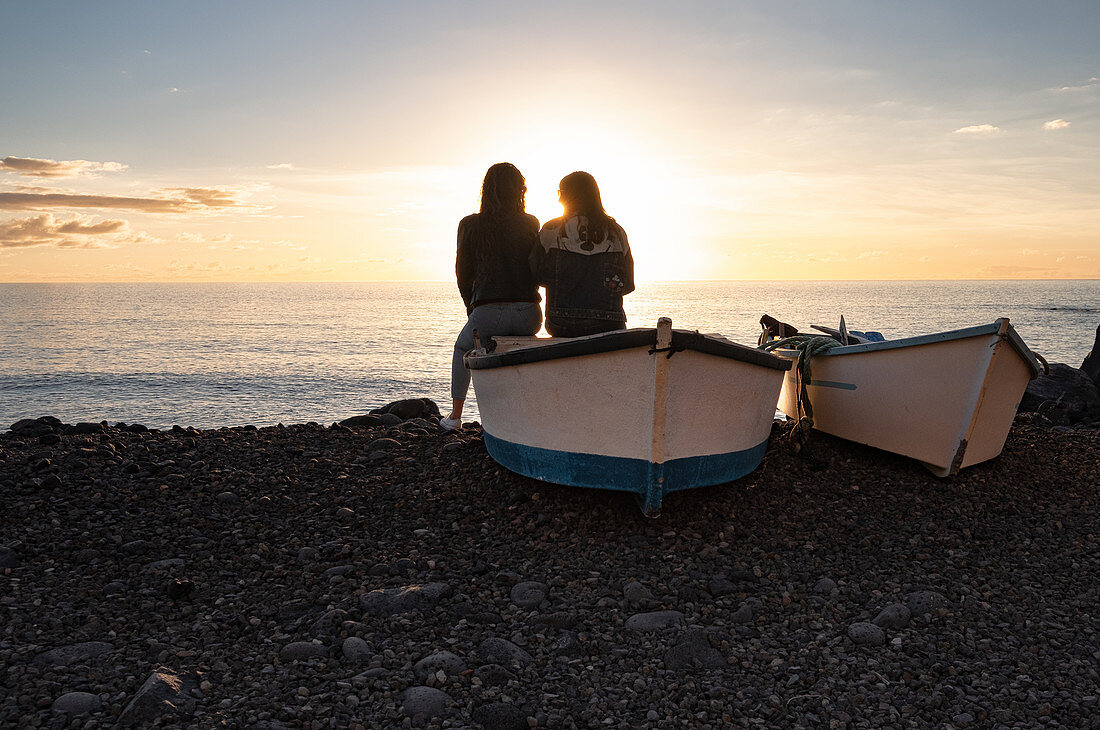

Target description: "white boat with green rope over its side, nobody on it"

left=776, top=319, right=1041, bottom=476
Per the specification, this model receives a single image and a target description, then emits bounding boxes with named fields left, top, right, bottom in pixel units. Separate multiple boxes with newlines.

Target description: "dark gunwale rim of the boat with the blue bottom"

left=464, top=328, right=793, bottom=370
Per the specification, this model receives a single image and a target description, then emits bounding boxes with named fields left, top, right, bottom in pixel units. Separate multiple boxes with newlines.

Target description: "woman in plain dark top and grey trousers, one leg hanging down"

left=440, top=163, right=542, bottom=431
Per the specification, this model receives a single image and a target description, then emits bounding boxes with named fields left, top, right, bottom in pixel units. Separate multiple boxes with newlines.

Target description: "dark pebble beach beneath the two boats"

left=0, top=413, right=1100, bottom=730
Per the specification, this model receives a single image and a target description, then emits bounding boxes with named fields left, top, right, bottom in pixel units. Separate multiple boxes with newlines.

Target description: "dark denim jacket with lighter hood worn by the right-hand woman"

left=531, top=215, right=634, bottom=329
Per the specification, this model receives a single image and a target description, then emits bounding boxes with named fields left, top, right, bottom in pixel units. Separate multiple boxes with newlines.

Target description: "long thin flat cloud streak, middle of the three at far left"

left=0, top=188, right=240, bottom=213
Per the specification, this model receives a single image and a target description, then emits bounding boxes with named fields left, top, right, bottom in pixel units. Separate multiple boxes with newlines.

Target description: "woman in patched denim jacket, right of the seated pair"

left=531, top=173, right=634, bottom=338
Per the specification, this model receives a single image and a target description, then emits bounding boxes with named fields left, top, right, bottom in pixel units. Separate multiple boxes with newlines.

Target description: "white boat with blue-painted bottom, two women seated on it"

left=465, top=318, right=791, bottom=515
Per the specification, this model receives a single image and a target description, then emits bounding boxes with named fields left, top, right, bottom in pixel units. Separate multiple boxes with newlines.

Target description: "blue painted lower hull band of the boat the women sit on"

left=484, top=432, right=768, bottom=515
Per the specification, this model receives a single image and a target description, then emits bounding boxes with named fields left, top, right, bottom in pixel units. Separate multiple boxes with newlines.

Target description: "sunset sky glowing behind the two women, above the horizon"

left=0, top=0, right=1100, bottom=281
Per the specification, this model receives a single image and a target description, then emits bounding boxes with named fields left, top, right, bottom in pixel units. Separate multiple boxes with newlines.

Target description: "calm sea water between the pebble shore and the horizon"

left=0, top=280, right=1100, bottom=428
